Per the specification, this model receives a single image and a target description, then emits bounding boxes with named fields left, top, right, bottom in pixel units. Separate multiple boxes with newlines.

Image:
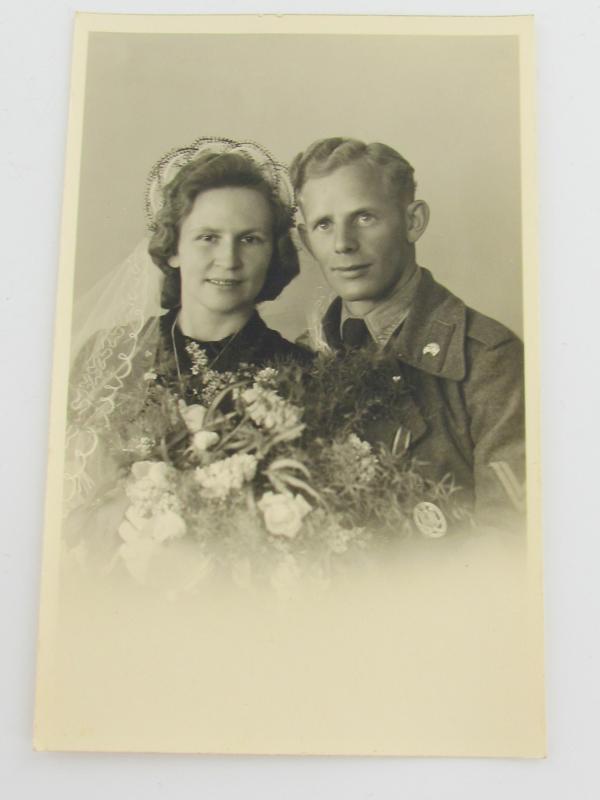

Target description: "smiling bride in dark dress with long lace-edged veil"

left=66, top=139, right=310, bottom=552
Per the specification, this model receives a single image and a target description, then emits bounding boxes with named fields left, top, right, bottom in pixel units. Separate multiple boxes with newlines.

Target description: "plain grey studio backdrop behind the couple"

left=75, top=33, right=523, bottom=338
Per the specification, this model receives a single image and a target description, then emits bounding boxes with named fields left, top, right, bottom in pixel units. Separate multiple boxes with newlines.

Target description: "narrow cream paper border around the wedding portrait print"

left=34, top=14, right=545, bottom=757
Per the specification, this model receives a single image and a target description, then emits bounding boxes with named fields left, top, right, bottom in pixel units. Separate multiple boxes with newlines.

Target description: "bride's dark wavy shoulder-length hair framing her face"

left=148, top=152, right=300, bottom=308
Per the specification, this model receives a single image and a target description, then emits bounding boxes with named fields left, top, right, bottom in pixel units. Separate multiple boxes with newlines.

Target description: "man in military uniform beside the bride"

left=291, top=138, right=525, bottom=523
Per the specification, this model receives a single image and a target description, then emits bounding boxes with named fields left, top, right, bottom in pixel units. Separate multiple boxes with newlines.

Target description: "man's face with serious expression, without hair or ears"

left=300, top=161, right=414, bottom=313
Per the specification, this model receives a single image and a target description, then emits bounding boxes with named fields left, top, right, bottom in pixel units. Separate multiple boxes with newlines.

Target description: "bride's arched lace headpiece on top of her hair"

left=145, top=136, right=295, bottom=228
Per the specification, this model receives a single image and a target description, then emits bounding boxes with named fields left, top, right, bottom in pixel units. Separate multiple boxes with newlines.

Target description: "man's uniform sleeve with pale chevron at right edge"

left=465, top=335, right=525, bottom=524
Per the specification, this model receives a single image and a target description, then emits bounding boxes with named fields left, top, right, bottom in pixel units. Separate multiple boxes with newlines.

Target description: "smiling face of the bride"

left=169, top=186, right=273, bottom=314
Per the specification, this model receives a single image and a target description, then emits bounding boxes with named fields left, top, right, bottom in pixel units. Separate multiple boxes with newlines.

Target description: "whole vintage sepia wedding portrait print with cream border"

left=35, top=15, right=544, bottom=756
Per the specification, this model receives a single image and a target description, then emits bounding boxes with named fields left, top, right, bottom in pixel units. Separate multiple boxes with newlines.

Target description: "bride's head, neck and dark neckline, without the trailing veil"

left=149, top=142, right=306, bottom=382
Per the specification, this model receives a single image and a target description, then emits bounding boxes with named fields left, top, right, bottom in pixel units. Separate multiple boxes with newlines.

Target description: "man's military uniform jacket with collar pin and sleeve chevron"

left=322, top=269, right=525, bottom=523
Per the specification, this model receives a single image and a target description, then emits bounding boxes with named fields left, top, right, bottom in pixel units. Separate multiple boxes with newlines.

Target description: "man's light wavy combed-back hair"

left=290, top=136, right=416, bottom=209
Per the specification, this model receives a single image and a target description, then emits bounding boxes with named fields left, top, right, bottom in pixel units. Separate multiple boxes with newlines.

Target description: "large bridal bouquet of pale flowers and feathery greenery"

left=79, top=348, right=464, bottom=584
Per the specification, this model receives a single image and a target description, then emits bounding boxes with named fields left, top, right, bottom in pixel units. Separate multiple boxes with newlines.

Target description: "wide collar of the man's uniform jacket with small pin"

left=323, top=268, right=467, bottom=381
